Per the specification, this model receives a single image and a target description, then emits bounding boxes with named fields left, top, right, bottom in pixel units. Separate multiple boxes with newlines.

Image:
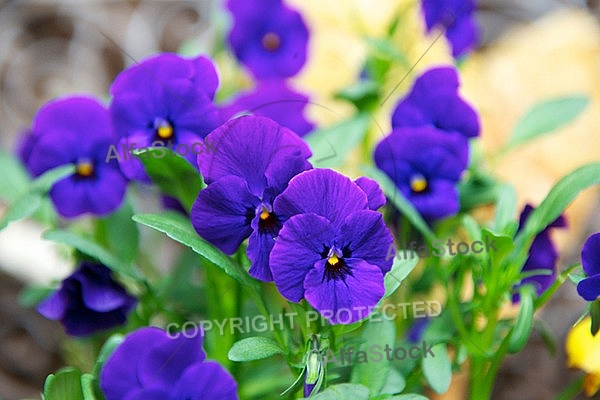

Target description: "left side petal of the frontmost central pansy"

left=270, top=214, right=334, bottom=302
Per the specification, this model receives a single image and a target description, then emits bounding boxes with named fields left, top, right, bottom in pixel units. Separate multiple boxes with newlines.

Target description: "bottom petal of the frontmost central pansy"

left=304, top=259, right=385, bottom=324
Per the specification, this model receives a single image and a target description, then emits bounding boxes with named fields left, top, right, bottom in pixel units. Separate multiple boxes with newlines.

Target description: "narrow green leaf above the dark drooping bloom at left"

left=42, top=230, right=141, bottom=280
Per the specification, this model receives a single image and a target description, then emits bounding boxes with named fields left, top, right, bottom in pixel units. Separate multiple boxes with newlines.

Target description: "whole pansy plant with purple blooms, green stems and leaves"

left=0, top=0, right=600, bottom=400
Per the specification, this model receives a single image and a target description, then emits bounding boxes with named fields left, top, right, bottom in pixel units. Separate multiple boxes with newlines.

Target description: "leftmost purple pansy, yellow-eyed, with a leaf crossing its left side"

left=23, top=97, right=127, bottom=218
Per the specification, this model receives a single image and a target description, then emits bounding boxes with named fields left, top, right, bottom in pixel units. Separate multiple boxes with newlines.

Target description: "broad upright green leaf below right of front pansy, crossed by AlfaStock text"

left=350, top=318, right=396, bottom=395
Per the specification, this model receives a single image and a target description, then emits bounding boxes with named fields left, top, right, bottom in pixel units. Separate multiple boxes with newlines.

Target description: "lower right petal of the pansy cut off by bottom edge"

left=170, top=361, right=238, bottom=400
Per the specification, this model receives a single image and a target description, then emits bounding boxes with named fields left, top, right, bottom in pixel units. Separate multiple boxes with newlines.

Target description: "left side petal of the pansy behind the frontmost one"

left=191, top=175, right=259, bottom=254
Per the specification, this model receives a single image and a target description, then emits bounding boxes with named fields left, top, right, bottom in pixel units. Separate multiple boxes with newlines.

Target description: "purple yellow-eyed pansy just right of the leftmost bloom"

left=110, top=53, right=223, bottom=182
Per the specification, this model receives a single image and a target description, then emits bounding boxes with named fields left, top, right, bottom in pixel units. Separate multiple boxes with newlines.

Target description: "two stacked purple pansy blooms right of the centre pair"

left=374, top=67, right=480, bottom=221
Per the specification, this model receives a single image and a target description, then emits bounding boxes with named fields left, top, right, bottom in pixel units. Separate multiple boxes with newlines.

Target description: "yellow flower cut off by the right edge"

left=566, top=317, right=600, bottom=397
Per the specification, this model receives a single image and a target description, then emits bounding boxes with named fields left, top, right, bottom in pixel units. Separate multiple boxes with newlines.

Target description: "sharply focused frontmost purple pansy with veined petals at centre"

left=270, top=169, right=393, bottom=324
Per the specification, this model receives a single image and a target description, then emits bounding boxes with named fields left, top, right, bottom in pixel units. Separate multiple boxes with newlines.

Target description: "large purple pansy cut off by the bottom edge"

left=100, top=327, right=238, bottom=400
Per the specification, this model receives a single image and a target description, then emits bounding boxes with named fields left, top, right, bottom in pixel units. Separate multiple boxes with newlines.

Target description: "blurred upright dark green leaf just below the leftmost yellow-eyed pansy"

left=98, top=200, right=140, bottom=262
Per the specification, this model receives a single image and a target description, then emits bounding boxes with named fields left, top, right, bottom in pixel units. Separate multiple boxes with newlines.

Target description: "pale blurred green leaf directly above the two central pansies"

left=304, top=114, right=370, bottom=168
